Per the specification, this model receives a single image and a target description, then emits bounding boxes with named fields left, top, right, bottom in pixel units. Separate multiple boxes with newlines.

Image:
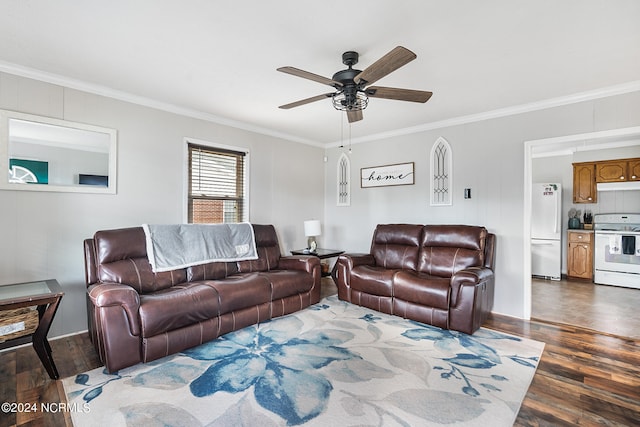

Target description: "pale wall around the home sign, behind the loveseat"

left=324, top=92, right=640, bottom=317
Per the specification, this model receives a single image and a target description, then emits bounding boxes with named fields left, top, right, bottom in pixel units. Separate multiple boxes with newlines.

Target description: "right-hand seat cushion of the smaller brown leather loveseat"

left=393, top=270, right=451, bottom=310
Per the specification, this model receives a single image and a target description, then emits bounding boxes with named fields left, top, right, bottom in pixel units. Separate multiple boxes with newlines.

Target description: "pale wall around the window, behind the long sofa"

left=0, top=73, right=324, bottom=337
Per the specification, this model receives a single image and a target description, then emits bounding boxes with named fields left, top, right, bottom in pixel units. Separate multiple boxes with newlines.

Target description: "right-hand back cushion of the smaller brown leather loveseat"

left=418, top=225, right=487, bottom=277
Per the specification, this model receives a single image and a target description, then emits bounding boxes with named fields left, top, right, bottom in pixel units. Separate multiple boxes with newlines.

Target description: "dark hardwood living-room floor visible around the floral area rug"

left=0, top=279, right=640, bottom=426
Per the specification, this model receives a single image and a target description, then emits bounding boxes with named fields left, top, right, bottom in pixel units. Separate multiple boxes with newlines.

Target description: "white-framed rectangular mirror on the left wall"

left=0, top=110, right=117, bottom=194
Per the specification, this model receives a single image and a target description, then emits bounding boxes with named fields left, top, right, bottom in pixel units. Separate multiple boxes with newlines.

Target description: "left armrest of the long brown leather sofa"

left=87, top=283, right=140, bottom=336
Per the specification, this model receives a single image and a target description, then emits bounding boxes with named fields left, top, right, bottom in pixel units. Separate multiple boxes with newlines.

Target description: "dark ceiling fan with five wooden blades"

left=278, top=46, right=433, bottom=123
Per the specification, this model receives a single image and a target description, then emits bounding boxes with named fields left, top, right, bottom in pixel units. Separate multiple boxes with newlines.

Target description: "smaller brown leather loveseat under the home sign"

left=332, top=224, right=495, bottom=334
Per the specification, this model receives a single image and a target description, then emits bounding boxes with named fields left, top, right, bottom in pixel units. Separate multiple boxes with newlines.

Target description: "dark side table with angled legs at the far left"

left=0, top=279, right=64, bottom=380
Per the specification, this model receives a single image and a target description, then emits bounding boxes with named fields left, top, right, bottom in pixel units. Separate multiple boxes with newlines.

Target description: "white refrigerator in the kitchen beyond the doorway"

left=531, top=183, right=562, bottom=280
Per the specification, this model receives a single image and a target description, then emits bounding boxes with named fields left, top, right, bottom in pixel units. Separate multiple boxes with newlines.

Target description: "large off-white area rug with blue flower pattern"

left=63, top=296, right=544, bottom=427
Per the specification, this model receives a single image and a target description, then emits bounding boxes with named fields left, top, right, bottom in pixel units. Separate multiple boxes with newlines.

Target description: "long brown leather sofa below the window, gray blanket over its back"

left=84, top=224, right=321, bottom=372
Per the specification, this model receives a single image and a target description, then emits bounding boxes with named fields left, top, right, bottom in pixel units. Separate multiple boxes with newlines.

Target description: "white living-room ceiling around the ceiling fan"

left=0, top=0, right=640, bottom=145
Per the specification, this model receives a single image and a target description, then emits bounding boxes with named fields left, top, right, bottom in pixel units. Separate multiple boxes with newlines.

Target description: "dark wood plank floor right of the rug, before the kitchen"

left=484, top=316, right=640, bottom=426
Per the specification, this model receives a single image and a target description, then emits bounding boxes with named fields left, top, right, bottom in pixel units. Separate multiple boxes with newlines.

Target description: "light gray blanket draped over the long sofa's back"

left=142, top=223, right=258, bottom=272
